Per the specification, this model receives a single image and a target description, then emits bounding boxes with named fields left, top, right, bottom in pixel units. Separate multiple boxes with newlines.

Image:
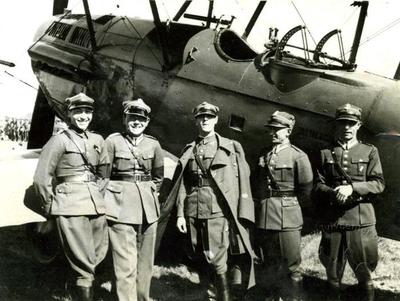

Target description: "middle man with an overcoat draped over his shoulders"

left=166, top=102, right=254, bottom=301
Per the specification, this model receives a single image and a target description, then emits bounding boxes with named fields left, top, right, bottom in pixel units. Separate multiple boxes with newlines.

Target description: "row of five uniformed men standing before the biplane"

left=34, top=93, right=384, bottom=301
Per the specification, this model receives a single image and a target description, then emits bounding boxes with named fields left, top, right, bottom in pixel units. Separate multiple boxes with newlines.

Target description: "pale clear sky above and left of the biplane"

left=0, top=0, right=400, bottom=118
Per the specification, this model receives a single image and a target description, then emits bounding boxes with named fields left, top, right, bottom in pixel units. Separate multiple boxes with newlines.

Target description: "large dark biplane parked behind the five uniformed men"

left=0, top=0, right=400, bottom=262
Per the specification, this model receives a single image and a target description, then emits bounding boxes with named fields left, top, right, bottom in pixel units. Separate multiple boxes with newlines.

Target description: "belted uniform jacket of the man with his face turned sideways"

left=255, top=143, right=313, bottom=231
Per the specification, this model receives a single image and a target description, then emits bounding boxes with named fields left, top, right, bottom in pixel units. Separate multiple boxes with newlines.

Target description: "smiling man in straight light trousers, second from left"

left=105, top=98, right=164, bottom=301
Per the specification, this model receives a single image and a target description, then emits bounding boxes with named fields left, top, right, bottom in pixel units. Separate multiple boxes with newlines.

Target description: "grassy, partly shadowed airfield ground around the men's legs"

left=0, top=141, right=400, bottom=301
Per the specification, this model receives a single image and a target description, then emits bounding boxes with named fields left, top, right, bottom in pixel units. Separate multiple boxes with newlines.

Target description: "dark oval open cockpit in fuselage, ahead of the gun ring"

left=215, top=29, right=257, bottom=61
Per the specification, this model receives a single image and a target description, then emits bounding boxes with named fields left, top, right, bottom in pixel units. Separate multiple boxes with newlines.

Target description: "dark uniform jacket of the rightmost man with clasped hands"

left=314, top=143, right=385, bottom=227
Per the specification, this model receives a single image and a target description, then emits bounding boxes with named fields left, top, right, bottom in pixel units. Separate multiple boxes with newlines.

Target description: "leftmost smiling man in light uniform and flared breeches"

left=34, top=93, right=109, bottom=300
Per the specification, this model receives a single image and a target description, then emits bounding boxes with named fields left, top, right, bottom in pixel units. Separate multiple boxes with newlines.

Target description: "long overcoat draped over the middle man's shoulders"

left=166, top=134, right=255, bottom=287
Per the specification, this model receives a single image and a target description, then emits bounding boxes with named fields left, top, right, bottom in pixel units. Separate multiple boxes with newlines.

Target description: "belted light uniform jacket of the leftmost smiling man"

left=33, top=129, right=110, bottom=215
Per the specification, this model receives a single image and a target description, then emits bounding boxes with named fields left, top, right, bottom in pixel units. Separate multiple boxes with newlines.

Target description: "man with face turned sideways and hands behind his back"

left=255, top=111, right=313, bottom=300
